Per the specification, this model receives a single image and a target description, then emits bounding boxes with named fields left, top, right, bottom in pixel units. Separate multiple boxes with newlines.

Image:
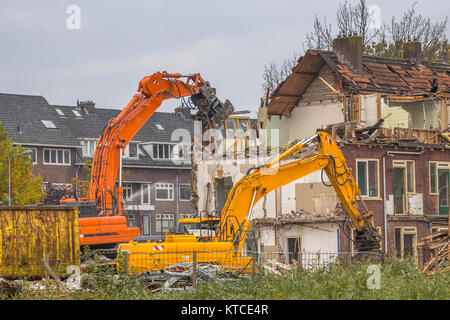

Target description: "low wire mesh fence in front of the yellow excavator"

left=117, top=250, right=379, bottom=274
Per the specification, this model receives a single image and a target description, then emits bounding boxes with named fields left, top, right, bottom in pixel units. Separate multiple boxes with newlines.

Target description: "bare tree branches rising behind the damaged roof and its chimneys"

left=263, top=0, right=449, bottom=94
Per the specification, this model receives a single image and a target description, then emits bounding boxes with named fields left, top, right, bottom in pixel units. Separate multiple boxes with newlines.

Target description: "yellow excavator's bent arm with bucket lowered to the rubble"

left=219, top=132, right=380, bottom=252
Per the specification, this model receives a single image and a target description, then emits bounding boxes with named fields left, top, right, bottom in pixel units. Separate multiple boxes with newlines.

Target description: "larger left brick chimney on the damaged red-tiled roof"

left=333, top=34, right=363, bottom=74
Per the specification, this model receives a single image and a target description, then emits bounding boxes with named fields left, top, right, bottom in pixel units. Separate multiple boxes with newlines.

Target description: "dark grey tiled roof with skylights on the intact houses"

left=0, top=93, right=194, bottom=166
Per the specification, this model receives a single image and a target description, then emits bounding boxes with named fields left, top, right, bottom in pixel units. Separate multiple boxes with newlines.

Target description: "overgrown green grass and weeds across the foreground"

left=4, top=258, right=450, bottom=300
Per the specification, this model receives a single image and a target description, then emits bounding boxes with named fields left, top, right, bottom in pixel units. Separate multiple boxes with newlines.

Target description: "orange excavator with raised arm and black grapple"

left=61, top=71, right=234, bottom=247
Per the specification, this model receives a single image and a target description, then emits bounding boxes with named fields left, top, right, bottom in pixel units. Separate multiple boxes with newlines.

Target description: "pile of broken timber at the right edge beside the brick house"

left=417, top=229, right=450, bottom=272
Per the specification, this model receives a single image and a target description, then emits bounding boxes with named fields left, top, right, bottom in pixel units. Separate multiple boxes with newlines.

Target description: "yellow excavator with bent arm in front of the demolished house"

left=118, top=131, right=380, bottom=273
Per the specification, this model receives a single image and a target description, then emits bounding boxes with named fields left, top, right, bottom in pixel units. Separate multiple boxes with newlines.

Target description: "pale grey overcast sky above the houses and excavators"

left=0, top=0, right=450, bottom=116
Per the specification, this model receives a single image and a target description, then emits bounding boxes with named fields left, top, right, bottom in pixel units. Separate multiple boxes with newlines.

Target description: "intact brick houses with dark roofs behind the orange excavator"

left=0, top=93, right=196, bottom=238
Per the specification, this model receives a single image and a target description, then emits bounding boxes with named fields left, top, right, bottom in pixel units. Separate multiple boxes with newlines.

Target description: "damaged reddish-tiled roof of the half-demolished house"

left=268, top=50, right=450, bottom=115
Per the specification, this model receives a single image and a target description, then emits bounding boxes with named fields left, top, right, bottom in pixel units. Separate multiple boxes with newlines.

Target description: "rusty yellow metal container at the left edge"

left=0, top=206, right=80, bottom=279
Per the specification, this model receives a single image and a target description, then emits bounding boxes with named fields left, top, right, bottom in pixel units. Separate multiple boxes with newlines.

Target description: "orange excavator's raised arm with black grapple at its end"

left=85, top=71, right=233, bottom=215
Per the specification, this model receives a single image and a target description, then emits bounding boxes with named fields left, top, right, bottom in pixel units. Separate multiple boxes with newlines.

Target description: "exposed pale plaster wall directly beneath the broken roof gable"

left=289, top=103, right=344, bottom=141
